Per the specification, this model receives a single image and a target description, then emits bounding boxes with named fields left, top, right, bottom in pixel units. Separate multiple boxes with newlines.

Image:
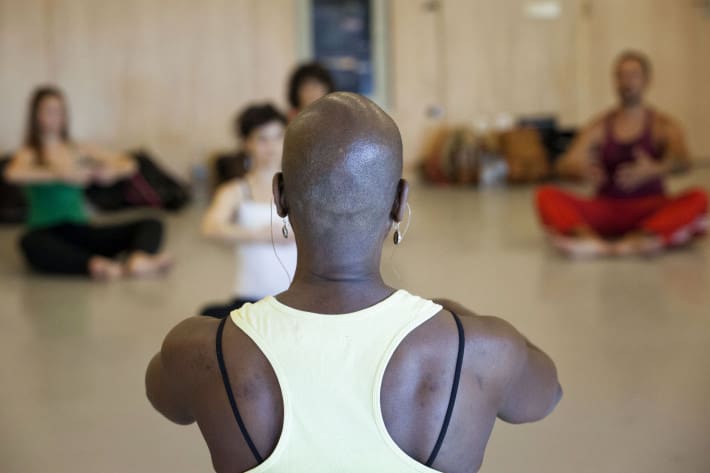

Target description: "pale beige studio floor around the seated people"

left=0, top=169, right=710, bottom=473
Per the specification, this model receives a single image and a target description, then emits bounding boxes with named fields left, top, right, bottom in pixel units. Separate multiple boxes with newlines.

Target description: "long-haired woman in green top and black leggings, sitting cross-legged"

left=6, top=87, right=171, bottom=280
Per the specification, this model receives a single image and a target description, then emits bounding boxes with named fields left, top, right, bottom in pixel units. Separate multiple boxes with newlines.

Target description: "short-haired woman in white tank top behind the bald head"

left=200, top=104, right=296, bottom=318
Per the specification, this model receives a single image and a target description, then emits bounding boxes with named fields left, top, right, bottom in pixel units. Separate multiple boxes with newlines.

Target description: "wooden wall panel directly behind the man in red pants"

left=580, top=0, right=710, bottom=158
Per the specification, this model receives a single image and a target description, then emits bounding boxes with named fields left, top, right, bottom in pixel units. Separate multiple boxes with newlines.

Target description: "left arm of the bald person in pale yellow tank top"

left=145, top=317, right=216, bottom=425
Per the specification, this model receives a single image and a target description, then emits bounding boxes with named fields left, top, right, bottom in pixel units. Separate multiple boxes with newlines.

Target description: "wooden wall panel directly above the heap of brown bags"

left=443, top=0, right=576, bottom=122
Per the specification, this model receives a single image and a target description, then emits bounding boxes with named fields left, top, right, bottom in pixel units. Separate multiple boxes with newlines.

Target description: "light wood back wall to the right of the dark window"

left=391, top=0, right=710, bottom=161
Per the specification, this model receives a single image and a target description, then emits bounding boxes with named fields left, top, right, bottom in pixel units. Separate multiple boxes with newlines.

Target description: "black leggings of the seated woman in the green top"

left=20, top=219, right=163, bottom=274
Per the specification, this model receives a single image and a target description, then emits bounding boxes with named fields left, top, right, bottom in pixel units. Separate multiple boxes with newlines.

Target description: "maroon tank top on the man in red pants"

left=597, top=110, right=665, bottom=199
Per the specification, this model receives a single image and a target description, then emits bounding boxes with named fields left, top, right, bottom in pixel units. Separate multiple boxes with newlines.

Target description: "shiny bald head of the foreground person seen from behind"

left=280, top=92, right=402, bottom=249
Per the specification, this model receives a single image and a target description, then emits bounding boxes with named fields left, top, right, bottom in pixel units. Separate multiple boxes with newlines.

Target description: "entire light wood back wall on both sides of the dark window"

left=0, top=0, right=710, bottom=173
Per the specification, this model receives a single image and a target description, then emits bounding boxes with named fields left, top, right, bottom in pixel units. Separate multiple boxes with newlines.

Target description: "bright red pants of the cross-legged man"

left=536, top=186, right=708, bottom=246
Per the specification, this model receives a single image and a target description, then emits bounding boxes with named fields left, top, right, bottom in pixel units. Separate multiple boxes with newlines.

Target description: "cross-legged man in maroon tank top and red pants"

left=537, top=51, right=708, bottom=257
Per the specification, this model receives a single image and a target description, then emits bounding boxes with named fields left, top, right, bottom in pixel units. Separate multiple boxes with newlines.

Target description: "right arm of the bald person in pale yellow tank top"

left=436, top=299, right=562, bottom=424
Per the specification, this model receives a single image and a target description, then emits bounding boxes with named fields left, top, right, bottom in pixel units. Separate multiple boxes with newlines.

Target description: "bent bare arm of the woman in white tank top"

left=202, top=181, right=278, bottom=243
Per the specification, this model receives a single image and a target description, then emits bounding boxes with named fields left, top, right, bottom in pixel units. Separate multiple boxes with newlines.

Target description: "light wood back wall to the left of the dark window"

left=0, top=0, right=296, bottom=174
